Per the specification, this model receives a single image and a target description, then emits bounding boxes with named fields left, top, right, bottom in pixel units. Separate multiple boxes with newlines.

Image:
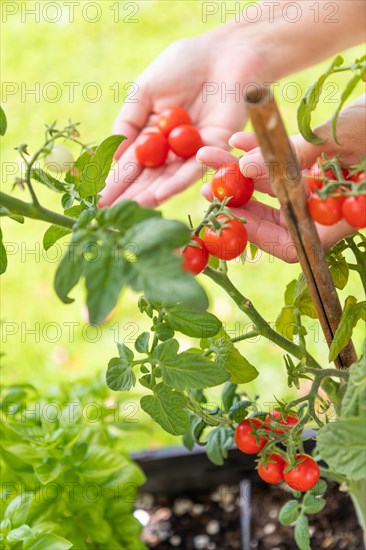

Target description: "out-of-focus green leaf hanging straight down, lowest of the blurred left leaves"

left=84, top=243, right=131, bottom=324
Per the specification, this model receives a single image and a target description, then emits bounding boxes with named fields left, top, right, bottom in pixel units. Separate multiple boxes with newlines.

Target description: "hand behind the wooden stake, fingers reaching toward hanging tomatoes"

left=197, top=96, right=366, bottom=262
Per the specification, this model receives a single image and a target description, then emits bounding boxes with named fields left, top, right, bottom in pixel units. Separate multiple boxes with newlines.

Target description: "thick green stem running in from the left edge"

left=0, top=191, right=76, bottom=229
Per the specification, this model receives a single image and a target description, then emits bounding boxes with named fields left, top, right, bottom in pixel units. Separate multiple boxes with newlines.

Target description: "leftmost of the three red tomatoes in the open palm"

left=135, top=130, right=169, bottom=168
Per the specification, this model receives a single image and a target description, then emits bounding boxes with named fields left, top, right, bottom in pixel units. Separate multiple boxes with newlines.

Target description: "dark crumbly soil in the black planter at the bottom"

left=137, top=483, right=364, bottom=550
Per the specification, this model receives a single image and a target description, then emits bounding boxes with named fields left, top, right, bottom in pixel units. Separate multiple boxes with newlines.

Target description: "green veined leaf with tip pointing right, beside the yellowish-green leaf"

left=153, top=340, right=229, bottom=391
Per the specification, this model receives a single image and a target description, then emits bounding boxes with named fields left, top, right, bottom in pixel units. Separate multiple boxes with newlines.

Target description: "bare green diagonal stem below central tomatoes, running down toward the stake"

left=204, top=267, right=321, bottom=369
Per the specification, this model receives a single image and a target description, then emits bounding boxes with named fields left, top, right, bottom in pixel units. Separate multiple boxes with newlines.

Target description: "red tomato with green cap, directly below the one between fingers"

left=203, top=214, right=248, bottom=260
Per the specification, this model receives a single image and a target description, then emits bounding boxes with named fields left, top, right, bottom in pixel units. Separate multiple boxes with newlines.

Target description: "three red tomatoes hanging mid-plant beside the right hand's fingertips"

left=182, top=164, right=254, bottom=275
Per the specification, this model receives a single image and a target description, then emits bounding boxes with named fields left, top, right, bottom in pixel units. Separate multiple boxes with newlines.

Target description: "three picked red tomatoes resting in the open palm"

left=135, top=107, right=203, bottom=168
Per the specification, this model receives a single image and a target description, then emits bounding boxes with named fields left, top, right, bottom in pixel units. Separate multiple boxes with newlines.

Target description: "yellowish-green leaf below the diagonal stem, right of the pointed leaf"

left=213, top=338, right=259, bottom=384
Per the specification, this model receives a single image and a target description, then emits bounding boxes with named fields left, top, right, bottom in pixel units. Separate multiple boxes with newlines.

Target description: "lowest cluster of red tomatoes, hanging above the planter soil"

left=235, top=411, right=320, bottom=492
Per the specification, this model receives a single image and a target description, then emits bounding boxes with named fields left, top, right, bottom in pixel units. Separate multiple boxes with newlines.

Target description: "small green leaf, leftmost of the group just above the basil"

left=106, top=344, right=136, bottom=391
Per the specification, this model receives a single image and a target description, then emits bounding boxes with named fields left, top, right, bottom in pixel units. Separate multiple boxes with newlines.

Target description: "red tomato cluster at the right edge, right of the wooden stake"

left=307, top=161, right=366, bottom=229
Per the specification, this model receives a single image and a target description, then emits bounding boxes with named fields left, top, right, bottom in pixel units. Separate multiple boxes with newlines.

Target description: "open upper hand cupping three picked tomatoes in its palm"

left=99, top=34, right=266, bottom=206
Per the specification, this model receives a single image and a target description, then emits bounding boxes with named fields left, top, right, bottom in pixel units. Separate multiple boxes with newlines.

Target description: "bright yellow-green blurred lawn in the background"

left=1, top=0, right=361, bottom=449
